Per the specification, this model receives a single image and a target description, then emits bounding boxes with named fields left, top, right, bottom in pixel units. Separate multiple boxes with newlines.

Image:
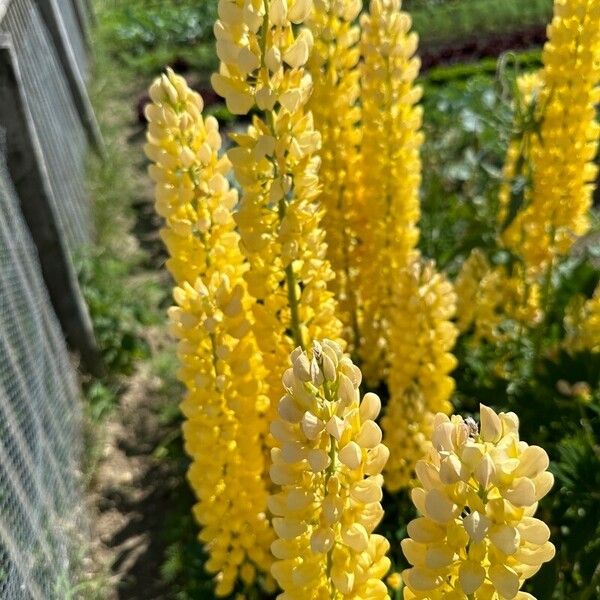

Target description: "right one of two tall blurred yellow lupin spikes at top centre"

left=359, top=0, right=423, bottom=382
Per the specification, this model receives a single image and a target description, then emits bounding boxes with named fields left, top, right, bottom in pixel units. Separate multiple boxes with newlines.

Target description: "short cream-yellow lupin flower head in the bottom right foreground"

left=402, top=404, right=554, bottom=600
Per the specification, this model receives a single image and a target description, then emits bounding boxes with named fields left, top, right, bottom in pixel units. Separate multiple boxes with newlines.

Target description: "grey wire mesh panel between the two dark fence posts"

left=0, top=0, right=91, bottom=252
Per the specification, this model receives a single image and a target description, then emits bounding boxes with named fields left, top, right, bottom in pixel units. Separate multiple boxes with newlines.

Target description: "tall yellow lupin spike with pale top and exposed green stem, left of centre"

left=212, top=0, right=341, bottom=422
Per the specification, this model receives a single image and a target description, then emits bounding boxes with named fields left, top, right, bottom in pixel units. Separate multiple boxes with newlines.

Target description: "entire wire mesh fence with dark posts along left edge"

left=0, top=0, right=97, bottom=600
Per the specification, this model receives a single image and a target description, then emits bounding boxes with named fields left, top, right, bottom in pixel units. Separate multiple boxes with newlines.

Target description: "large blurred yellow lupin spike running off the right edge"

left=503, top=0, right=600, bottom=277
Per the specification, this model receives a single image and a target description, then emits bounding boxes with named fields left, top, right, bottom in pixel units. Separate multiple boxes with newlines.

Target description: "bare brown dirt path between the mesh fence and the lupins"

left=90, top=354, right=185, bottom=600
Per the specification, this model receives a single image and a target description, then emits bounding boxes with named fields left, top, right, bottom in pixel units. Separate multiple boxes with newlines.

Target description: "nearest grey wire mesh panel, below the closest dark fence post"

left=0, top=140, right=85, bottom=600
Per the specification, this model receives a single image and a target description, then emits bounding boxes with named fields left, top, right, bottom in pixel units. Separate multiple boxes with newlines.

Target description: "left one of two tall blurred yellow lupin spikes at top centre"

left=308, top=0, right=362, bottom=350
